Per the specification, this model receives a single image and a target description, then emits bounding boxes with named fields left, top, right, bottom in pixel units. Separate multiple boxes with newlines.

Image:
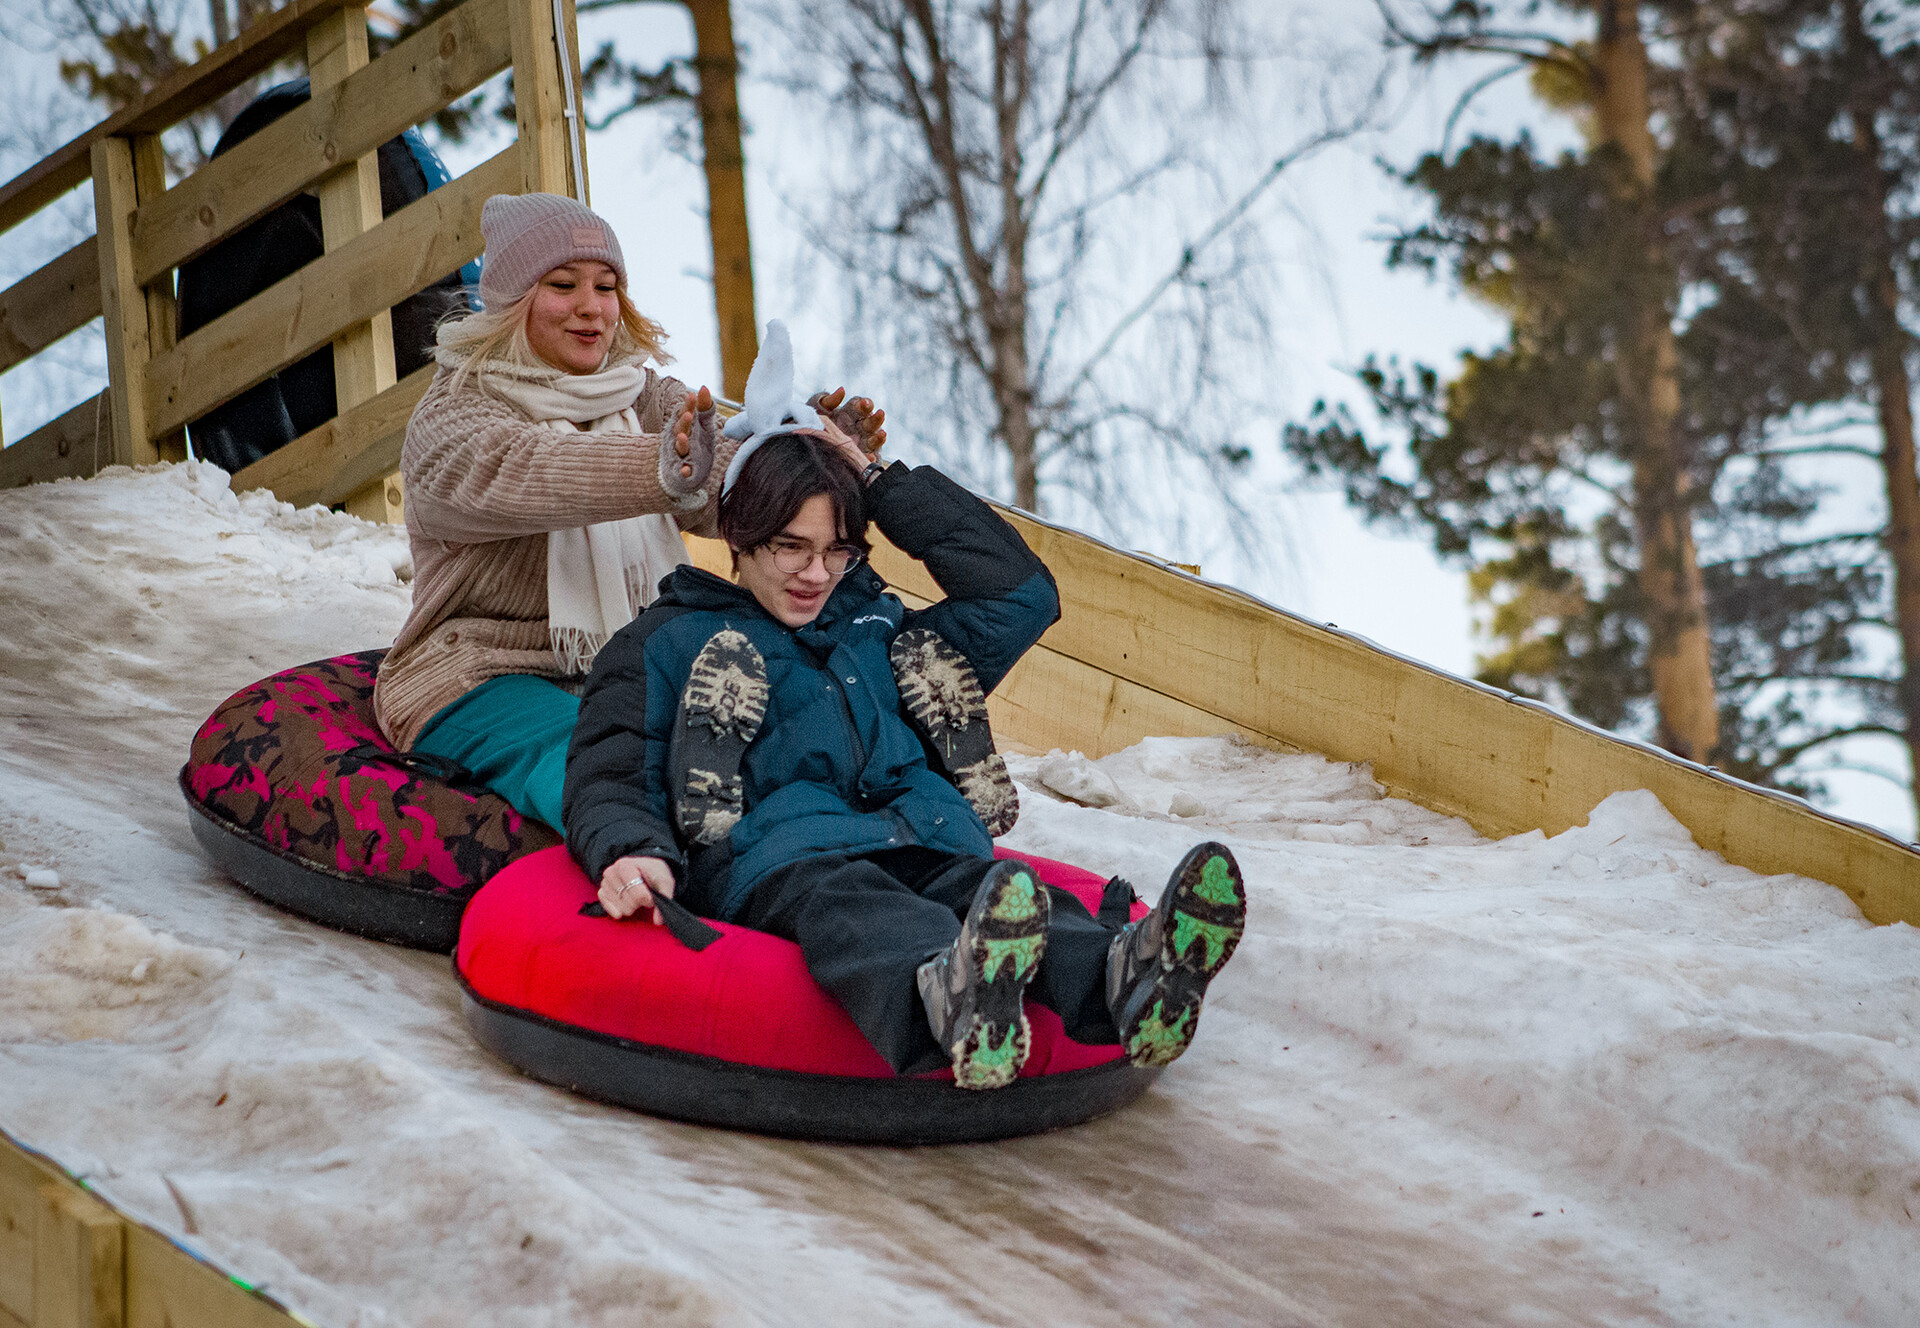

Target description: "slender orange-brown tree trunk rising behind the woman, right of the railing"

left=687, top=0, right=760, bottom=401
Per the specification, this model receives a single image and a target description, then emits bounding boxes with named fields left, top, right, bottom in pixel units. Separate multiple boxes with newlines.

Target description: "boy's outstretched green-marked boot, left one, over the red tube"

left=914, top=862, right=1052, bottom=1088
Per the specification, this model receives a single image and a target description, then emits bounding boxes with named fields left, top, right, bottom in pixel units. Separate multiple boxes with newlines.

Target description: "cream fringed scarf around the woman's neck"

left=438, top=349, right=707, bottom=674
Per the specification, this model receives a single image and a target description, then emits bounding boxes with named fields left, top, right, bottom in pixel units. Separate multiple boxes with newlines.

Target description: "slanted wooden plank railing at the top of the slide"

left=0, top=0, right=586, bottom=520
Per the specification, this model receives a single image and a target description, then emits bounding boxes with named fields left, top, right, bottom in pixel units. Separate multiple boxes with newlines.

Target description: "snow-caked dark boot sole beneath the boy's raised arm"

left=887, top=628, right=1020, bottom=837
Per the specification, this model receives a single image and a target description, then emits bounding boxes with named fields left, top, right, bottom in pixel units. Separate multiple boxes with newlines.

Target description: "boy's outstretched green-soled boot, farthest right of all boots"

left=1106, top=842, right=1246, bottom=1067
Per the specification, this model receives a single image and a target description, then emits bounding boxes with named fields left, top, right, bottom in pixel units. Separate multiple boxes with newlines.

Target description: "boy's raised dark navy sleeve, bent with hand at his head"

left=866, top=462, right=1060, bottom=691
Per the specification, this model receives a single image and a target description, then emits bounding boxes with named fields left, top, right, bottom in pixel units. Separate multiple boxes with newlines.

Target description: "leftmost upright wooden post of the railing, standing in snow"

left=92, top=136, right=159, bottom=466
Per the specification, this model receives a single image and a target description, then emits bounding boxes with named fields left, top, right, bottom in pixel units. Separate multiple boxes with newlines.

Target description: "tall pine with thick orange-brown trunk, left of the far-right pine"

left=1288, top=0, right=1904, bottom=789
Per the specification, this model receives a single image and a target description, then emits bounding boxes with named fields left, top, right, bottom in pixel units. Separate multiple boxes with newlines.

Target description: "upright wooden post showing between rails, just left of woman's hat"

left=307, top=6, right=399, bottom=520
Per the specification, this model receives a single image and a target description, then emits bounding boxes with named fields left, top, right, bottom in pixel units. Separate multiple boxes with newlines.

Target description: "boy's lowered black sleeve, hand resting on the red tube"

left=561, top=610, right=685, bottom=885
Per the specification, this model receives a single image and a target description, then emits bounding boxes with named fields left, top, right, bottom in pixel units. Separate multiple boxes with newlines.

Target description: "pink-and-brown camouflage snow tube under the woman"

left=180, top=651, right=559, bottom=952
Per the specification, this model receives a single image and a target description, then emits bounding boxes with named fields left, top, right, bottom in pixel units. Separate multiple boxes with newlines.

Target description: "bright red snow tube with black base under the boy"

left=453, top=848, right=1160, bottom=1144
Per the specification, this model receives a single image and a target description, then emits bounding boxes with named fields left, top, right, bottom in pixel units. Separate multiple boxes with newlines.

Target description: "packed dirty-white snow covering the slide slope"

left=0, top=462, right=1920, bottom=1328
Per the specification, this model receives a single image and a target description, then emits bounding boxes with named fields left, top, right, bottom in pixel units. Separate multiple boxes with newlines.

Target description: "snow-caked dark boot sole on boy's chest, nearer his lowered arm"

left=666, top=628, right=766, bottom=844
